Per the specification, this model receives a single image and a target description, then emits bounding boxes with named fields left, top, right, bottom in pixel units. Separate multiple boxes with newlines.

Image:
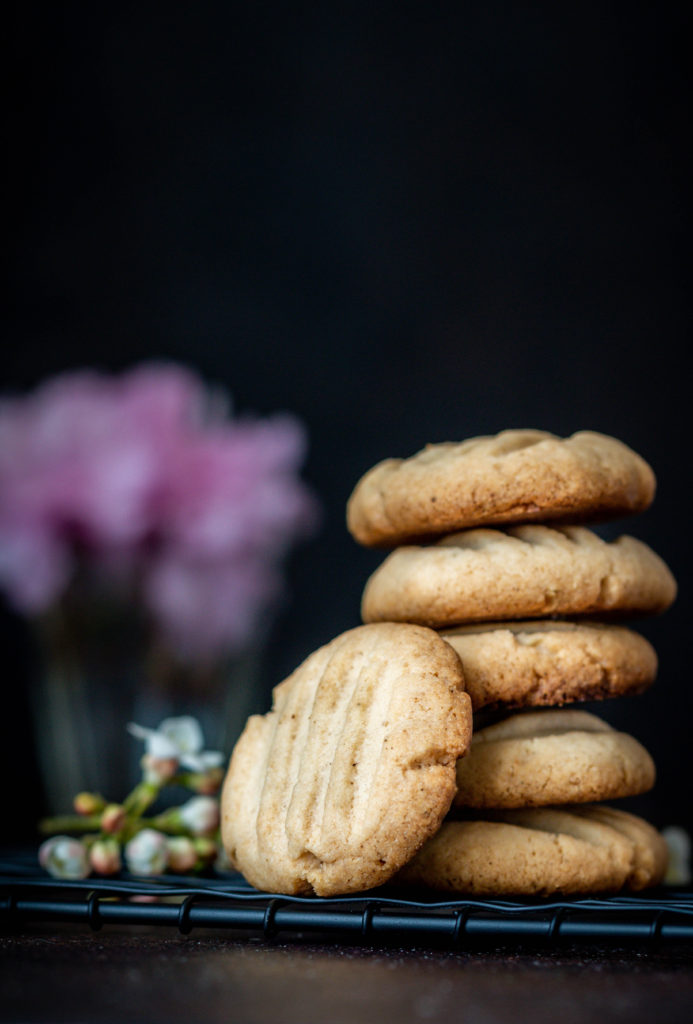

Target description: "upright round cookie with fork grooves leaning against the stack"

left=221, top=624, right=472, bottom=896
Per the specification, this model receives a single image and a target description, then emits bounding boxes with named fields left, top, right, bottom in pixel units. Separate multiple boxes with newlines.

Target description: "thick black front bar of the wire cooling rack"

left=5, top=892, right=693, bottom=944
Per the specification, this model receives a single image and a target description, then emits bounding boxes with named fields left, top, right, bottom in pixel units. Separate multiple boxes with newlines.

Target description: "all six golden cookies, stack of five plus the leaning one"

left=221, top=430, right=676, bottom=896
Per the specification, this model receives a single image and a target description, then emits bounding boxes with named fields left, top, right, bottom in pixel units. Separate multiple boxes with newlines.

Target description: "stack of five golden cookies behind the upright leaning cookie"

left=347, top=430, right=676, bottom=895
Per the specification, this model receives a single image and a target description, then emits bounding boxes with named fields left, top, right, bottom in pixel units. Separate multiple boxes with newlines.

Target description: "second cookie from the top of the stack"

left=361, top=525, right=677, bottom=629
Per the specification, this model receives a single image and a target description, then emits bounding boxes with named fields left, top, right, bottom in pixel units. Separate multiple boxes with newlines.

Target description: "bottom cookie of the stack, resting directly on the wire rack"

left=395, top=807, right=666, bottom=897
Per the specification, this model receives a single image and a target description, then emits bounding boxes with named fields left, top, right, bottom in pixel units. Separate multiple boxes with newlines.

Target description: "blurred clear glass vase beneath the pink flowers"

left=27, top=595, right=262, bottom=814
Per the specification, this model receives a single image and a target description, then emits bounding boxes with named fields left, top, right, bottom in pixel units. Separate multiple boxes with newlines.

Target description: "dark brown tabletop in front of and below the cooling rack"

left=0, top=924, right=693, bottom=1024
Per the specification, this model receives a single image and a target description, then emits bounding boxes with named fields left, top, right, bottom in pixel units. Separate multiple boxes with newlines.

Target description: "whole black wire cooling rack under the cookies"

left=0, top=856, right=693, bottom=946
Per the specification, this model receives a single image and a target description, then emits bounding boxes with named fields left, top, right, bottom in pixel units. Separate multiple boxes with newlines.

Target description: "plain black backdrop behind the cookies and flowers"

left=2, top=2, right=693, bottom=836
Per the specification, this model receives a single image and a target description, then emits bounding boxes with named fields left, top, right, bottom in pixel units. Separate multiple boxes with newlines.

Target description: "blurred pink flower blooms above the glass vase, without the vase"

left=0, top=365, right=316, bottom=659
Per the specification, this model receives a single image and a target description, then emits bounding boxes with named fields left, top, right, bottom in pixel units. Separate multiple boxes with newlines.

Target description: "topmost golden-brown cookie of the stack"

left=347, top=430, right=655, bottom=547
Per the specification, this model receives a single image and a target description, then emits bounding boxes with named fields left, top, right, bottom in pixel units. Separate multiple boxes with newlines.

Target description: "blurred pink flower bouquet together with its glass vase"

left=0, top=365, right=317, bottom=810
